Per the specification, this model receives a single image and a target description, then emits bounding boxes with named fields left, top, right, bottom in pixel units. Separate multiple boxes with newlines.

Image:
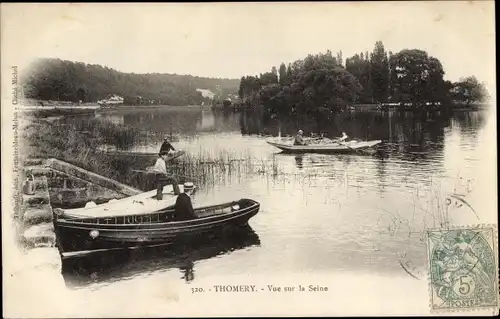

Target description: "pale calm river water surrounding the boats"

left=4, top=109, right=496, bottom=316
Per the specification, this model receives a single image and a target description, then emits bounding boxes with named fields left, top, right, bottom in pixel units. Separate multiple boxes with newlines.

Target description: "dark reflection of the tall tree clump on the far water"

left=239, top=111, right=484, bottom=150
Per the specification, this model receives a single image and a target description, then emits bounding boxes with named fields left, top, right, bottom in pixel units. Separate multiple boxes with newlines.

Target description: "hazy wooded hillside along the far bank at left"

left=20, top=58, right=239, bottom=105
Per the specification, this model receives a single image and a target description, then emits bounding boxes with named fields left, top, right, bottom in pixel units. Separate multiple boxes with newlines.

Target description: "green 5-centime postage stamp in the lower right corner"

left=427, top=226, right=499, bottom=311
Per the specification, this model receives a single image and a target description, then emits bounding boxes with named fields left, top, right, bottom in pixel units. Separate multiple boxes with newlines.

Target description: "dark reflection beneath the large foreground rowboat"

left=62, top=226, right=260, bottom=288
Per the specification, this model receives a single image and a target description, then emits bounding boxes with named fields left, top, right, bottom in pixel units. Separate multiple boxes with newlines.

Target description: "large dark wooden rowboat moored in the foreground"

left=53, top=199, right=260, bottom=258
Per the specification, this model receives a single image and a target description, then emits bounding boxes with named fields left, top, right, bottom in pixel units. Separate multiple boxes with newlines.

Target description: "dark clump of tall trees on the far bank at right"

left=238, top=41, right=488, bottom=115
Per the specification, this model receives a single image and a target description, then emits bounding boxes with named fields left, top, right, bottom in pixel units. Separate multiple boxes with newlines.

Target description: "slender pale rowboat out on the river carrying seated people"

left=267, top=140, right=382, bottom=153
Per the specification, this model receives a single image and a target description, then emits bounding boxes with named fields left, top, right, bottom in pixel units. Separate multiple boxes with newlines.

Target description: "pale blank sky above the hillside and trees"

left=1, top=1, right=496, bottom=85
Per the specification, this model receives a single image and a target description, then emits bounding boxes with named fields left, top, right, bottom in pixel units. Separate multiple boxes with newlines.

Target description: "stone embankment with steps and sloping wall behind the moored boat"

left=15, top=159, right=140, bottom=247
